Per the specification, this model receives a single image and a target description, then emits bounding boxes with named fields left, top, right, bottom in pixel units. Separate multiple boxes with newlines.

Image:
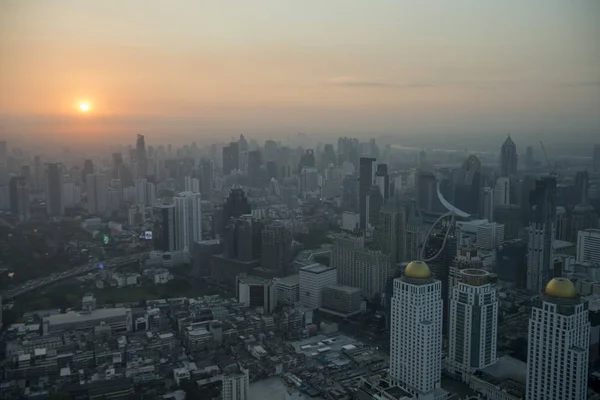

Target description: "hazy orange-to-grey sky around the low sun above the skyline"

left=0, top=0, right=600, bottom=145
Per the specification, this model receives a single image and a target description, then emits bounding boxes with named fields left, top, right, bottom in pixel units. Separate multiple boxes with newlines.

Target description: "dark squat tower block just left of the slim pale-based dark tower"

left=496, top=239, right=527, bottom=289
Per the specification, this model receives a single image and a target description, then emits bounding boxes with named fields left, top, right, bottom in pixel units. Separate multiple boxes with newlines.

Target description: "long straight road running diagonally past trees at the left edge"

left=0, top=252, right=150, bottom=300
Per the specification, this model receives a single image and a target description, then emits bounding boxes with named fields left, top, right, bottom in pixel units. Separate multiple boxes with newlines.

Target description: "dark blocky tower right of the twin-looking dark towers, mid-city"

left=261, top=221, right=292, bottom=276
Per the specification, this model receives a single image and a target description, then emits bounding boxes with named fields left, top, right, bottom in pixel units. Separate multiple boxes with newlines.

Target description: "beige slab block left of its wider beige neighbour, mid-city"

left=331, top=234, right=364, bottom=287
